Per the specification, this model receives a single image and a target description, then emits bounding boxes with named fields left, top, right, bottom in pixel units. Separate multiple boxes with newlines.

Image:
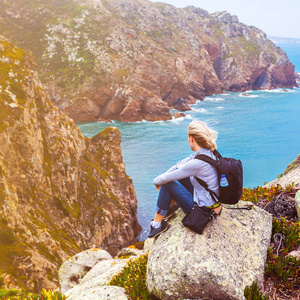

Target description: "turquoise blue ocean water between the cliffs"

left=78, top=42, right=300, bottom=240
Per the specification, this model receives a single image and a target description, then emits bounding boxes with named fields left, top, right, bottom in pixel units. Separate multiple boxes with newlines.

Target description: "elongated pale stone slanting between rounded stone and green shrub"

left=65, top=259, right=128, bottom=300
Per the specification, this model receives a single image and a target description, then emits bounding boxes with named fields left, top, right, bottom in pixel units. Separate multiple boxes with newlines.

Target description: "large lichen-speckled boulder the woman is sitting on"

left=147, top=201, right=272, bottom=300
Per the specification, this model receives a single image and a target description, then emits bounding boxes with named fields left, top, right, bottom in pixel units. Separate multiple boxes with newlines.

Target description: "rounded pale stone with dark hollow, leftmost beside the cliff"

left=58, top=248, right=112, bottom=293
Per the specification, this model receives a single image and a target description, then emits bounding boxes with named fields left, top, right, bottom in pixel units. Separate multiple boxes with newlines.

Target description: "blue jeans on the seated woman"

left=156, top=178, right=194, bottom=216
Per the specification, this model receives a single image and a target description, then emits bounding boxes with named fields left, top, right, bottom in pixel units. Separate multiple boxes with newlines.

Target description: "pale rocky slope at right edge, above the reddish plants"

left=263, top=155, right=300, bottom=189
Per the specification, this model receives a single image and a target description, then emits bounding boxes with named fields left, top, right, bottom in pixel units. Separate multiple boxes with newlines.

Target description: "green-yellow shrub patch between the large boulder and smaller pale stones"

left=108, top=254, right=154, bottom=300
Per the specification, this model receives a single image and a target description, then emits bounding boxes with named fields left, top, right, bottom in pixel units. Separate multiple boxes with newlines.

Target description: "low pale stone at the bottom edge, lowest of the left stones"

left=68, top=286, right=129, bottom=300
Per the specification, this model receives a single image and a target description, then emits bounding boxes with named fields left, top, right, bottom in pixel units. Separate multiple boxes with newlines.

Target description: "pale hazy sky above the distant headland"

left=150, top=0, right=300, bottom=38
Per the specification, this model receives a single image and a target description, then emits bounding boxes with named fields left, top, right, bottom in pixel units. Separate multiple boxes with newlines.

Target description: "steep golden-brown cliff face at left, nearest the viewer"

left=0, top=37, right=139, bottom=290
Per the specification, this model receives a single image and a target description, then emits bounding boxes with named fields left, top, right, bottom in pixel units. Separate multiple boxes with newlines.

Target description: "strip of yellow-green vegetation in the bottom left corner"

left=0, top=289, right=66, bottom=300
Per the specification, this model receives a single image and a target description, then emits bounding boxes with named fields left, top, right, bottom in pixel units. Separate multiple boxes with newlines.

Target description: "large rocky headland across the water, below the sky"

left=0, top=0, right=296, bottom=121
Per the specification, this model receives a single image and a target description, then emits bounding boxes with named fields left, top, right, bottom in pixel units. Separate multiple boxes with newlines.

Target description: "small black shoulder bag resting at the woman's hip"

left=181, top=202, right=214, bottom=234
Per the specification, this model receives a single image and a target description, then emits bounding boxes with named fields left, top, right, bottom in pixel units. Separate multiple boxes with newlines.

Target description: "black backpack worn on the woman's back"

left=195, top=150, right=243, bottom=204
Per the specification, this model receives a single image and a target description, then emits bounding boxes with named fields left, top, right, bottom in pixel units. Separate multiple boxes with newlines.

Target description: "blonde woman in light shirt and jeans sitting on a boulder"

left=148, top=121, right=222, bottom=238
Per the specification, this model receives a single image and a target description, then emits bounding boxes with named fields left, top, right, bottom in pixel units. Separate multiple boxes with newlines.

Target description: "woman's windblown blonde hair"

left=188, top=121, right=218, bottom=151
